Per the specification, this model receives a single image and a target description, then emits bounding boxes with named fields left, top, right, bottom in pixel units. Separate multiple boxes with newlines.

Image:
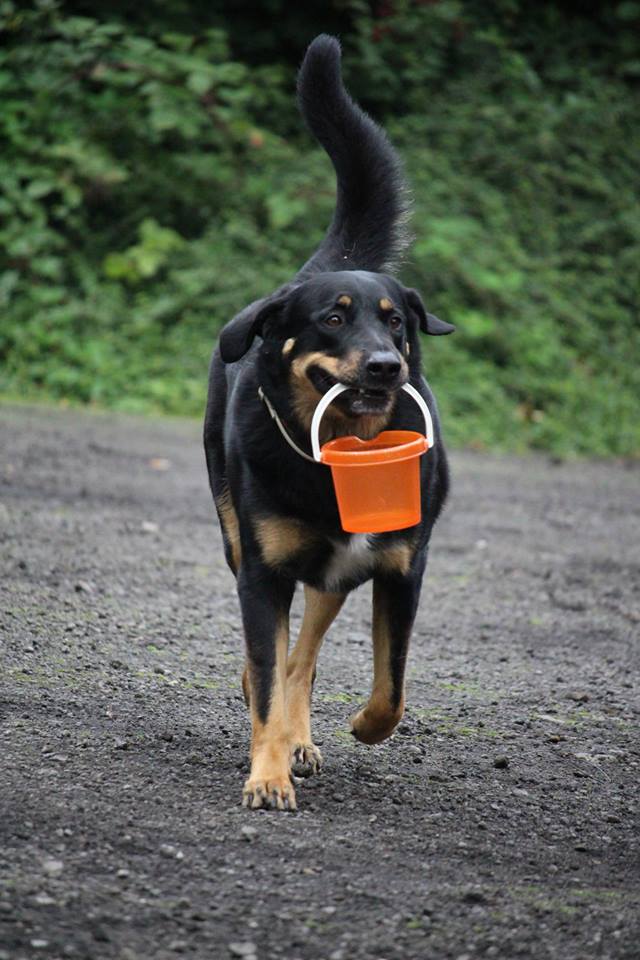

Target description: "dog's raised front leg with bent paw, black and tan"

left=351, top=558, right=424, bottom=744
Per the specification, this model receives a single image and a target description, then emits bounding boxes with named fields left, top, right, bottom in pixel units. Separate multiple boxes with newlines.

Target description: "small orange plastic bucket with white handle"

left=311, top=384, right=433, bottom=533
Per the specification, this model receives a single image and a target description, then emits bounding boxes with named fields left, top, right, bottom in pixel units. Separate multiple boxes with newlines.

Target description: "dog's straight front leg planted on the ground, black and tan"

left=238, top=559, right=296, bottom=810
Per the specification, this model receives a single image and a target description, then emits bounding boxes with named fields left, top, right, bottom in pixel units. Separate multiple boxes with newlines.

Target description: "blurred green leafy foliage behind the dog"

left=0, top=0, right=640, bottom=455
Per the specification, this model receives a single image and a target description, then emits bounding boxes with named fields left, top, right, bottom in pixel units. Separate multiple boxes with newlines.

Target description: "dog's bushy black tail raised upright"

left=298, top=34, right=410, bottom=279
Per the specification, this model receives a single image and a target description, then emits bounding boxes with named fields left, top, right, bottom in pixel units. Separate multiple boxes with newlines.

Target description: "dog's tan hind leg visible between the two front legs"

left=287, top=586, right=345, bottom=777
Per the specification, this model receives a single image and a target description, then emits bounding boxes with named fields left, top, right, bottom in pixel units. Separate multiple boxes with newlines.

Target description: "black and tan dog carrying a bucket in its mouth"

left=205, top=36, right=453, bottom=810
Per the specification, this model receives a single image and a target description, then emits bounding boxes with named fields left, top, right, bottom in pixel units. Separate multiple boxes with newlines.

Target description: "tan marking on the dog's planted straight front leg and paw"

left=242, top=617, right=296, bottom=810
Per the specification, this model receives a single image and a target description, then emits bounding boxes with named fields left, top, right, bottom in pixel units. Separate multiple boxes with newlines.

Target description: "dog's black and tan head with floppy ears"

left=220, top=270, right=454, bottom=436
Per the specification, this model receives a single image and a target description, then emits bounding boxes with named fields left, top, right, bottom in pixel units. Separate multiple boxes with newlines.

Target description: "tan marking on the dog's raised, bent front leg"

left=351, top=580, right=404, bottom=744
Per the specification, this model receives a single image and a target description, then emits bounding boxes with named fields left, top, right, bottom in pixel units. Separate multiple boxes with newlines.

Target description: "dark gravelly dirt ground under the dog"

left=0, top=407, right=640, bottom=960
